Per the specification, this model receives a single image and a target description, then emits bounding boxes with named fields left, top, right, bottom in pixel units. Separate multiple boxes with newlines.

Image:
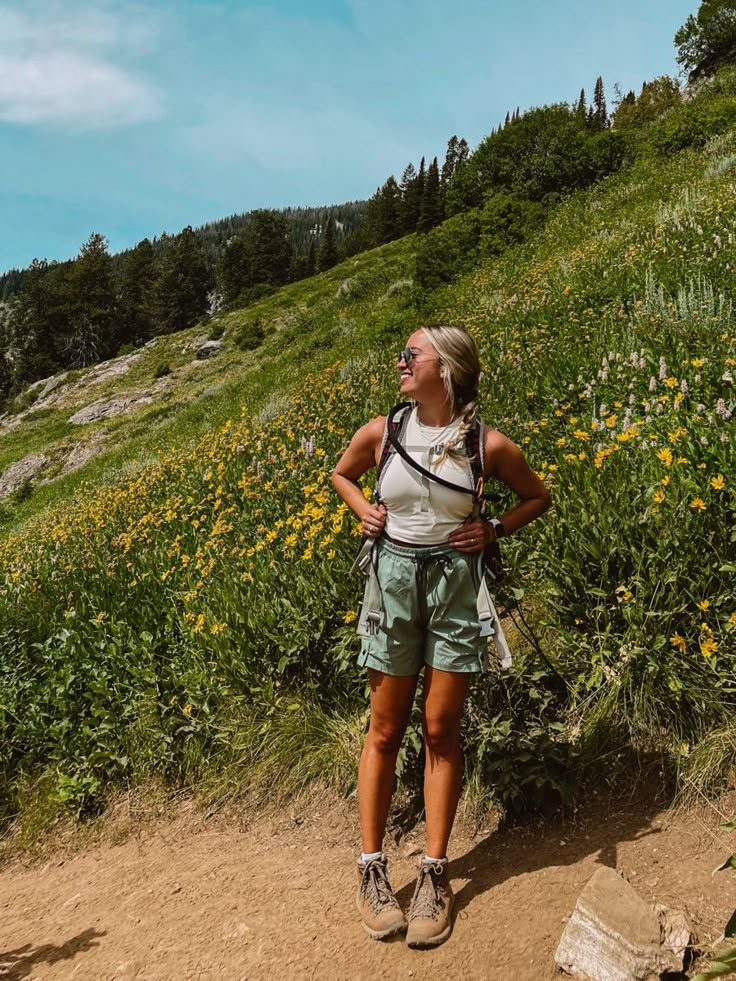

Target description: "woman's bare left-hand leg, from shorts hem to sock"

left=358, top=668, right=419, bottom=853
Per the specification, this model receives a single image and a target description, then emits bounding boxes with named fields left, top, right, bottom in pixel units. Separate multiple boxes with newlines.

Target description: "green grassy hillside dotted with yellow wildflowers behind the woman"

left=0, top=122, right=736, bottom=828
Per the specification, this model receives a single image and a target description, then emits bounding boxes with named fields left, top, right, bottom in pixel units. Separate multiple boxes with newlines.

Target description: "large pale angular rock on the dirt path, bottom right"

left=555, top=868, right=682, bottom=981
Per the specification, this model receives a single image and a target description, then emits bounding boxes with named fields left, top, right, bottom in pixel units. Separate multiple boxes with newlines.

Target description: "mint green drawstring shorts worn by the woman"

left=358, top=538, right=488, bottom=675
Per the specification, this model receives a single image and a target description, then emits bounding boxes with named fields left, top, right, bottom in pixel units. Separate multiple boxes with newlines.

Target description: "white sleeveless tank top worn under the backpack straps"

left=380, top=406, right=473, bottom=545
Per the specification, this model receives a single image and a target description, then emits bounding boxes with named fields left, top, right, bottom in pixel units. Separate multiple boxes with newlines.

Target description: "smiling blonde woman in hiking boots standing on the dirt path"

left=332, top=326, right=552, bottom=947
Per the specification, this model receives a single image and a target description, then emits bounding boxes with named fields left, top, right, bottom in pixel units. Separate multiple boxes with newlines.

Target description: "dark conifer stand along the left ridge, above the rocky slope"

left=0, top=209, right=355, bottom=405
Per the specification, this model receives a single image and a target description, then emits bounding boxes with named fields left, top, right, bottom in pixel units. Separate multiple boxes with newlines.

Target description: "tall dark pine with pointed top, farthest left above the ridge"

left=63, top=232, right=118, bottom=368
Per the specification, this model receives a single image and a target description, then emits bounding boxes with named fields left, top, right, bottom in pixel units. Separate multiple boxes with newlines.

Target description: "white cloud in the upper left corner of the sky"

left=0, top=0, right=162, bottom=129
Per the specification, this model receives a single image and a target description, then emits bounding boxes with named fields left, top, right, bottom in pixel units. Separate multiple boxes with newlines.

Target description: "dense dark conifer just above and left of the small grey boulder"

left=156, top=225, right=211, bottom=334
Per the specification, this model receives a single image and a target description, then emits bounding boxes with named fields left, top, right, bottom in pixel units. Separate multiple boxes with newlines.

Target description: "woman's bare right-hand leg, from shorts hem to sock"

left=422, top=665, right=470, bottom=858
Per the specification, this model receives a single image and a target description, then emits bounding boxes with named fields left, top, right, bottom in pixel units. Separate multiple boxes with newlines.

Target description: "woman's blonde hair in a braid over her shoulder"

left=421, top=324, right=480, bottom=462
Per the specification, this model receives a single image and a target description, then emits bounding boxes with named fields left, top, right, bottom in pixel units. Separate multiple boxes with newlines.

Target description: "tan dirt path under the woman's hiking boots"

left=0, top=799, right=736, bottom=981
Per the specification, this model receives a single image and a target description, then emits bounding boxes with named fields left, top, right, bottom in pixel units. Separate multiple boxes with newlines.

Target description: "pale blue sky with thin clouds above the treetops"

left=0, top=0, right=698, bottom=269
